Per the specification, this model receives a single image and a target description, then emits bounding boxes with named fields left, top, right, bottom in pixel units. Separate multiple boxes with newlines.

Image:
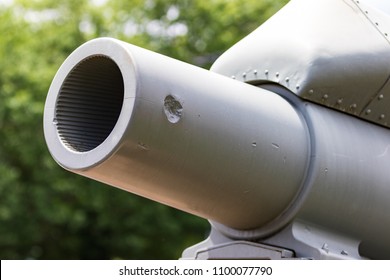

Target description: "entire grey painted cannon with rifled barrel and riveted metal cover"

left=44, top=0, right=390, bottom=259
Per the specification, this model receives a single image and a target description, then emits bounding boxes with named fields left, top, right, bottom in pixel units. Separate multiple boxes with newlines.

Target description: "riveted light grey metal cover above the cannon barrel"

left=211, top=0, right=390, bottom=127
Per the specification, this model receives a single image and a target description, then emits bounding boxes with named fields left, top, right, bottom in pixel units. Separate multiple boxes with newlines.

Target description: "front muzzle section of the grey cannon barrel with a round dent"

left=44, top=38, right=310, bottom=231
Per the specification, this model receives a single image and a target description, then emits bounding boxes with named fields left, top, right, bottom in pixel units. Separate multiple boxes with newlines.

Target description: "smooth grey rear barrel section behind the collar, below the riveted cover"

left=298, top=104, right=390, bottom=258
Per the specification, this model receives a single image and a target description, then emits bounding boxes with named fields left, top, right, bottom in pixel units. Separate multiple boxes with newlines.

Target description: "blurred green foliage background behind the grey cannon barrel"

left=0, top=0, right=287, bottom=259
